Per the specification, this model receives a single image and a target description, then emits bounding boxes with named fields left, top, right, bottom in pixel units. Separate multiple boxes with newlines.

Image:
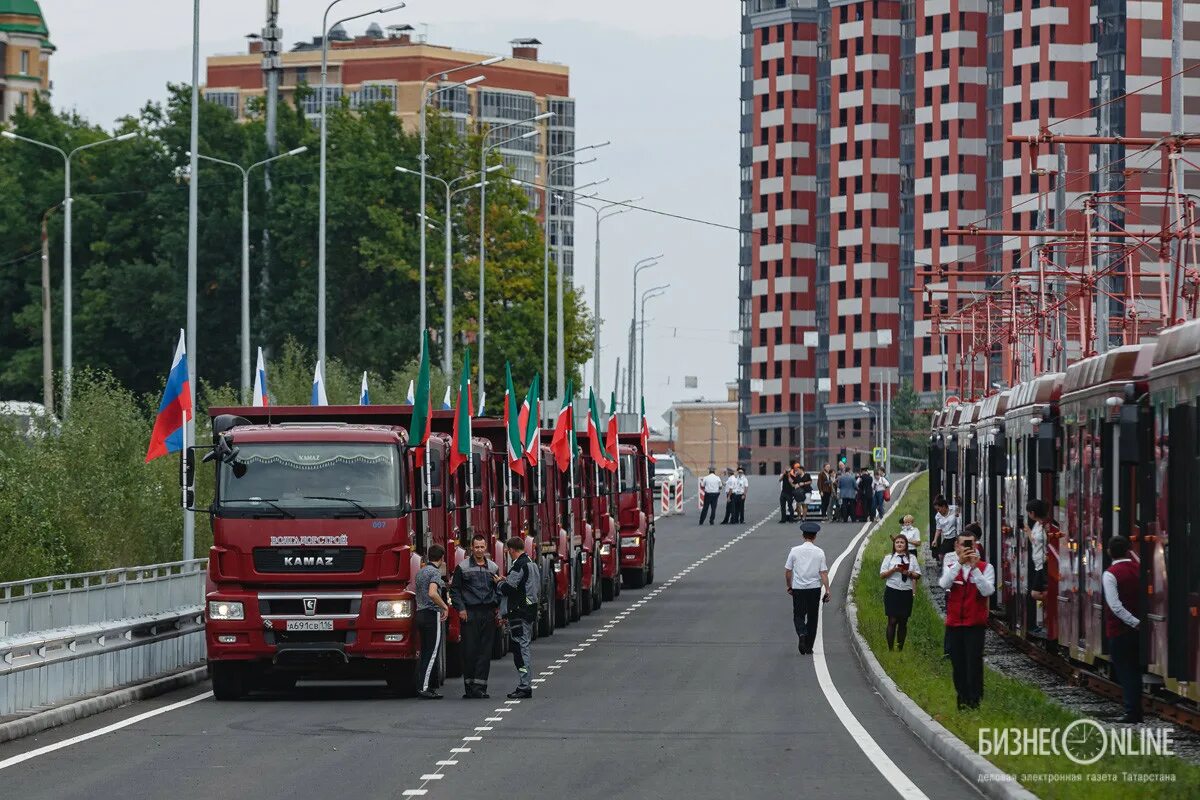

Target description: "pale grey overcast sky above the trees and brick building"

left=41, top=0, right=738, bottom=425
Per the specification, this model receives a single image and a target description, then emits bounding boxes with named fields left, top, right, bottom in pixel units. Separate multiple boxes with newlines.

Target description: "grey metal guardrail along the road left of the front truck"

left=0, top=559, right=206, bottom=716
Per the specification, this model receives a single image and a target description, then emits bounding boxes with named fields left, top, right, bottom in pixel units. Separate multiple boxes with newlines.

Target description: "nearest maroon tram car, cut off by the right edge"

left=1134, top=320, right=1200, bottom=702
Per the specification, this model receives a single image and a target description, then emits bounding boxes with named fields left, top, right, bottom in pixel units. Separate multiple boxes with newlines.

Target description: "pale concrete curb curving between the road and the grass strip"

left=846, top=481, right=1038, bottom=800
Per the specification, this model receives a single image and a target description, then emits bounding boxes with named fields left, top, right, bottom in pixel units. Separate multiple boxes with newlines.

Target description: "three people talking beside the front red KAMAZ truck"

left=414, top=534, right=541, bottom=700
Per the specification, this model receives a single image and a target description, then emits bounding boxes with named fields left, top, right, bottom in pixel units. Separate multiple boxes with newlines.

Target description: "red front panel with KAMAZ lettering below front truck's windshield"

left=209, top=517, right=412, bottom=585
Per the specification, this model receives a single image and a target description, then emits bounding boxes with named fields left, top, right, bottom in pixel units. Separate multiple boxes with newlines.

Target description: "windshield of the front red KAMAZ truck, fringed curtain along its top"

left=218, top=441, right=402, bottom=513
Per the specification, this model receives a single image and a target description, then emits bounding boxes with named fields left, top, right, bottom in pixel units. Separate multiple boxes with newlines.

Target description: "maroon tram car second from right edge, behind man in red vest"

left=1065, top=344, right=1156, bottom=663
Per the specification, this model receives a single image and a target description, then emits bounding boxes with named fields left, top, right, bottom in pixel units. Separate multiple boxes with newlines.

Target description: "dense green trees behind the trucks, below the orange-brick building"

left=0, top=86, right=592, bottom=402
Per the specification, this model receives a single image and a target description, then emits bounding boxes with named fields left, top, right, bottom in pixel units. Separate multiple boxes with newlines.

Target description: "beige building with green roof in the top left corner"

left=0, top=0, right=54, bottom=122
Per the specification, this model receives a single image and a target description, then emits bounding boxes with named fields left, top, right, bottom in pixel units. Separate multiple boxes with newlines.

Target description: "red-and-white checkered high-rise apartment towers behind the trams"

left=738, top=0, right=1200, bottom=471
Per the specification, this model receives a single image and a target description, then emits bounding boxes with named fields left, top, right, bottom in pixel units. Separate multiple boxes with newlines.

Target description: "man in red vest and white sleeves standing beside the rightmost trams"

left=1100, top=536, right=1141, bottom=722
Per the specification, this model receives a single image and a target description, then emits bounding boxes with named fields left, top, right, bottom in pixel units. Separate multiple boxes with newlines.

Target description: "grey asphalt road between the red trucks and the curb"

left=0, top=479, right=977, bottom=800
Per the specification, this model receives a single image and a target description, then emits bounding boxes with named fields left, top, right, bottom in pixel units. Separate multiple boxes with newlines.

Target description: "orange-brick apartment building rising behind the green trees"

left=207, top=25, right=576, bottom=281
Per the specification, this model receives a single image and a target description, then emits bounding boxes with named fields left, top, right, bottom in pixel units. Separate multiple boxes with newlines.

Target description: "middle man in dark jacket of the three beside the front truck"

left=450, top=534, right=500, bottom=699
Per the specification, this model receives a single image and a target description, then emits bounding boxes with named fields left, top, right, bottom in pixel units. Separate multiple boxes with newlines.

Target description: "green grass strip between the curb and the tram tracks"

left=851, top=475, right=1200, bottom=800
